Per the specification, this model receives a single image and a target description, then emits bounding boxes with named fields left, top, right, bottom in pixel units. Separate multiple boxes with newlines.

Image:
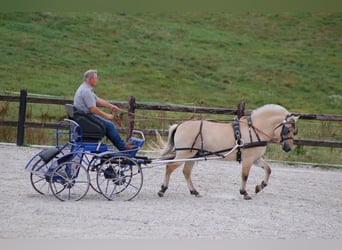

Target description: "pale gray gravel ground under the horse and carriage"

left=0, top=144, right=342, bottom=239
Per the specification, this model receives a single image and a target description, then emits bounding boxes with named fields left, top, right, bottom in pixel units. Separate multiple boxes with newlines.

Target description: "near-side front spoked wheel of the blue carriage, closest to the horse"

left=97, top=156, right=143, bottom=201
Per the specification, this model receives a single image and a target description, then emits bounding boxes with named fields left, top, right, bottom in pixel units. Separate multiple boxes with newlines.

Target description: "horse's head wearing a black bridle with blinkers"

left=274, top=114, right=299, bottom=152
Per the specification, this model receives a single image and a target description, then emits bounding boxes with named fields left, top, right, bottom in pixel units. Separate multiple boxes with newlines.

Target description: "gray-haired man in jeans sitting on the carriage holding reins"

left=74, top=70, right=136, bottom=151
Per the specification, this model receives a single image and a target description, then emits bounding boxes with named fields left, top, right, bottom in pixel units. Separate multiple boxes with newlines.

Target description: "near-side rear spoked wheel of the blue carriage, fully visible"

left=50, top=161, right=90, bottom=201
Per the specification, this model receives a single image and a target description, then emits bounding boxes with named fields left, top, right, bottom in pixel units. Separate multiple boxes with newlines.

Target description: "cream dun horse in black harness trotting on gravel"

left=158, top=104, right=299, bottom=200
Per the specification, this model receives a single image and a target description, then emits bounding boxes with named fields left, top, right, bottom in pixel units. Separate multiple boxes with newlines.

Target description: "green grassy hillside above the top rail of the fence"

left=0, top=12, right=342, bottom=114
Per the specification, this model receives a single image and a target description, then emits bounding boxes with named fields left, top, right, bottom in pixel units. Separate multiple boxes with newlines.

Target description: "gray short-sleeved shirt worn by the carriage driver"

left=74, top=82, right=97, bottom=113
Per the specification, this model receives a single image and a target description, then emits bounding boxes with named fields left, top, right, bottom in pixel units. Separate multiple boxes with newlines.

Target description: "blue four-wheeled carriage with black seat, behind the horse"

left=25, top=105, right=147, bottom=201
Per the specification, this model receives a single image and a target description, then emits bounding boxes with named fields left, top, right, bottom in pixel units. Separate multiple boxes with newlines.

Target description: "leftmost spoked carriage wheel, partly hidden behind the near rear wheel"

left=30, top=156, right=50, bottom=195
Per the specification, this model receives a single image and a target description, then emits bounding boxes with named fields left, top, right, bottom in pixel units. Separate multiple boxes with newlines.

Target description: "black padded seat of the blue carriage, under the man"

left=65, top=104, right=106, bottom=142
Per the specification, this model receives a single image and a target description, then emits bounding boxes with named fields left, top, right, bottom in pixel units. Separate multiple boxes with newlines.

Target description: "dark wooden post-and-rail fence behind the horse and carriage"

left=0, top=90, right=342, bottom=148
